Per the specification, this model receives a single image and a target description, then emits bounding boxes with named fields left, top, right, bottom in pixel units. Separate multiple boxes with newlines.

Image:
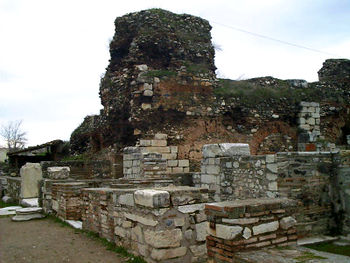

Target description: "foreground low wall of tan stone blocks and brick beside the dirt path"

left=83, top=187, right=212, bottom=262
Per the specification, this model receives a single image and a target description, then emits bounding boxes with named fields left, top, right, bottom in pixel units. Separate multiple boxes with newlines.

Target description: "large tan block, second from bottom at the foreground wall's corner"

left=144, top=228, right=182, bottom=248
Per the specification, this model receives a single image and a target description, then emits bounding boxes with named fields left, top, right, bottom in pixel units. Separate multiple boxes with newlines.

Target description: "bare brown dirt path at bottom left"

left=0, top=217, right=126, bottom=263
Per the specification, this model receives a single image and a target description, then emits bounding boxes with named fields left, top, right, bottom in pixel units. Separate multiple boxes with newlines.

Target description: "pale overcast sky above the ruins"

left=0, top=0, right=350, bottom=145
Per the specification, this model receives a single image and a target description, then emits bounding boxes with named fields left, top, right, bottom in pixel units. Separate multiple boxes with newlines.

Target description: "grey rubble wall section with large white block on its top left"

left=195, top=143, right=278, bottom=201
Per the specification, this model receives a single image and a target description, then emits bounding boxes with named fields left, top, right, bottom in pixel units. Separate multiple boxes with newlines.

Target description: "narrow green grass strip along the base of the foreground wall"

left=48, top=215, right=147, bottom=263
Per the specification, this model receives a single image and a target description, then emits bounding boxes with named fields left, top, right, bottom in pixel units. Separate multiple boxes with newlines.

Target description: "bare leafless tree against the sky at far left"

left=0, top=121, right=27, bottom=152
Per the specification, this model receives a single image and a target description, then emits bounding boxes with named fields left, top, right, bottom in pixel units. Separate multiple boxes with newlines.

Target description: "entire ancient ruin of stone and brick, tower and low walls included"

left=1, top=9, right=350, bottom=263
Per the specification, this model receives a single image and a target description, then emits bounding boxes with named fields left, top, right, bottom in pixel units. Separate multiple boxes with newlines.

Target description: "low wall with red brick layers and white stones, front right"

left=205, top=198, right=297, bottom=263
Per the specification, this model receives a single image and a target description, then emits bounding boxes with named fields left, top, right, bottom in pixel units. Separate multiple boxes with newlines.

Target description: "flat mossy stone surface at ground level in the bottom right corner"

left=235, top=246, right=350, bottom=263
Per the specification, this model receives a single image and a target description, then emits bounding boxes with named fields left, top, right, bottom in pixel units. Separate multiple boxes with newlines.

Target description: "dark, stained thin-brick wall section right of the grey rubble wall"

left=277, top=152, right=338, bottom=237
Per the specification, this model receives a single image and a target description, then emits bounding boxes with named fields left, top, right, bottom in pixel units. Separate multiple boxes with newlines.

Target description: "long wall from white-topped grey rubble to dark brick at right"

left=193, top=144, right=349, bottom=237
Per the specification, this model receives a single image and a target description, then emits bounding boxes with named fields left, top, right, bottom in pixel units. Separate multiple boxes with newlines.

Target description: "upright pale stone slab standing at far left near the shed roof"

left=20, top=163, right=43, bottom=198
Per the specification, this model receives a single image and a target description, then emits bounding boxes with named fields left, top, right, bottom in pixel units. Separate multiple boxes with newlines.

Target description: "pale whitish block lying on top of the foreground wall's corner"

left=134, top=189, right=170, bottom=208
